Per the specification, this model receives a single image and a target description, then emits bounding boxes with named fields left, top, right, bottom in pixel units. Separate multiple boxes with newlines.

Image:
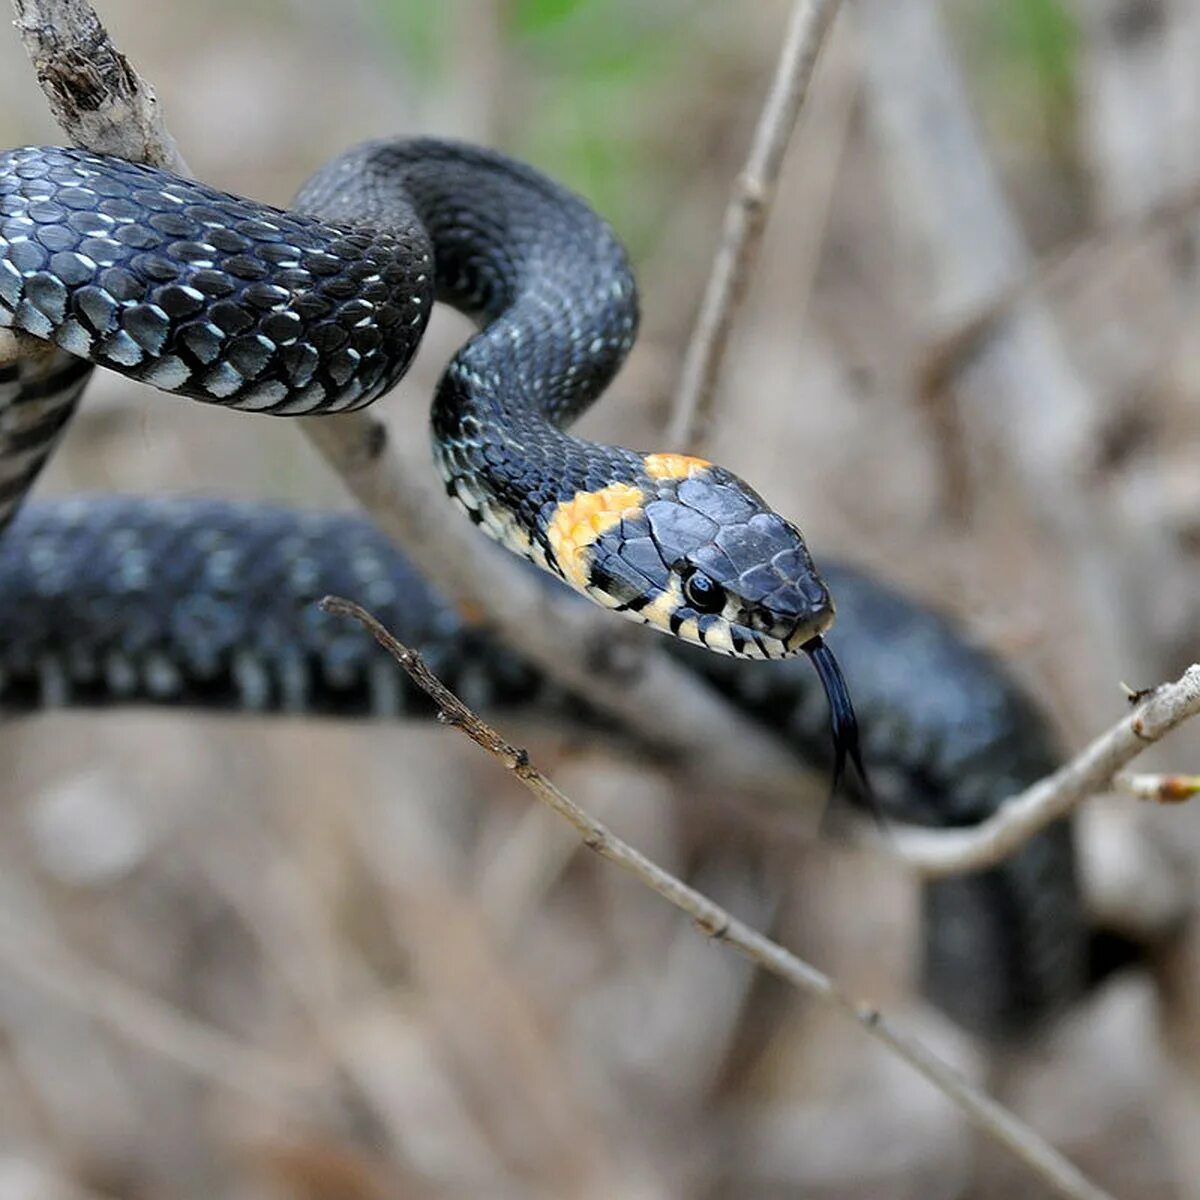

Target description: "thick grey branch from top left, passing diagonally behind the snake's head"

left=11, top=0, right=817, bottom=822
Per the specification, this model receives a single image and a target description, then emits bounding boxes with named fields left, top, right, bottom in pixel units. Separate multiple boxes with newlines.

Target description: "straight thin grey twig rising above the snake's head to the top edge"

left=667, top=0, right=838, bottom=450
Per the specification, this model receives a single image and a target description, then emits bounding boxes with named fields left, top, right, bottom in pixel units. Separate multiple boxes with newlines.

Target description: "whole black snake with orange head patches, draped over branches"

left=0, top=138, right=1087, bottom=1033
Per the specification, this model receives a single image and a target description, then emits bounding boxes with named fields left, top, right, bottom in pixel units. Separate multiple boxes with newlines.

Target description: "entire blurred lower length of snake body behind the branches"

left=0, top=497, right=1086, bottom=1037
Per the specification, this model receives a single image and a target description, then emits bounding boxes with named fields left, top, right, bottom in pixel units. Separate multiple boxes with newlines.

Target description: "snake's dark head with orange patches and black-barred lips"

left=548, top=455, right=834, bottom=659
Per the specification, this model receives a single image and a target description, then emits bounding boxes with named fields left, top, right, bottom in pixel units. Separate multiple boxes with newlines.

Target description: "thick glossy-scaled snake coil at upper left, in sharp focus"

left=0, top=146, right=433, bottom=414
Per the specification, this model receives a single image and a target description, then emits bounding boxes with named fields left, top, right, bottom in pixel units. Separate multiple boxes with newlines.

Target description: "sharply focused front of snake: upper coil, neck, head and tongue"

left=0, top=139, right=856, bottom=796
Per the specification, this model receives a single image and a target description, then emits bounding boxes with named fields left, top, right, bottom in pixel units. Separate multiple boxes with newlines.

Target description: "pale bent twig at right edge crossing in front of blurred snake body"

left=884, top=664, right=1200, bottom=878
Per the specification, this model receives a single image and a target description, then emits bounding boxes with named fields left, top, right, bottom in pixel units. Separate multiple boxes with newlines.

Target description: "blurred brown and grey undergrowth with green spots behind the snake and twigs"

left=0, top=0, right=1200, bottom=1200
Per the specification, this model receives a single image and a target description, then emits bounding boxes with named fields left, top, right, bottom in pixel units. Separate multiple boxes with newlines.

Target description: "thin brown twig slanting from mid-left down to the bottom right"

left=320, top=596, right=1113, bottom=1200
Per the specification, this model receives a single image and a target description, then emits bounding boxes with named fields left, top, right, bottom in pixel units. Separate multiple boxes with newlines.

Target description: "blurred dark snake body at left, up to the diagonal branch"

left=0, top=496, right=549, bottom=718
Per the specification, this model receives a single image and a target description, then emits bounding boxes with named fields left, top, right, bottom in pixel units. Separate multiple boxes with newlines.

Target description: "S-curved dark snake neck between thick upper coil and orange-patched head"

left=296, top=139, right=644, bottom=566
